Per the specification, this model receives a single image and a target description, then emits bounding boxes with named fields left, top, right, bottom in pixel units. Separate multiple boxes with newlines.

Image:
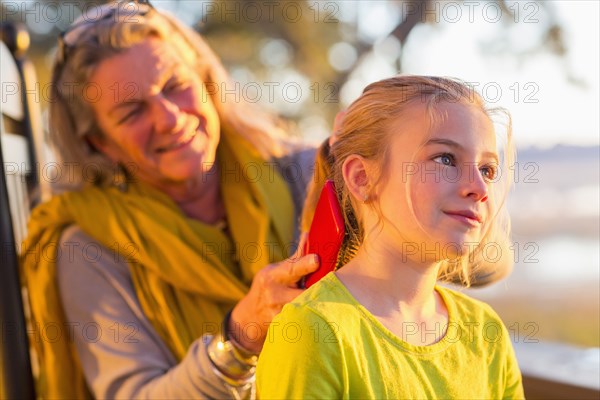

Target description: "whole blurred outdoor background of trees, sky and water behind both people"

left=1, top=0, right=600, bottom=388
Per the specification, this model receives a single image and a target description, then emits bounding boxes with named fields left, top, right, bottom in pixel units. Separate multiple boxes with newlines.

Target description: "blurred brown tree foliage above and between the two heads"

left=200, top=0, right=571, bottom=141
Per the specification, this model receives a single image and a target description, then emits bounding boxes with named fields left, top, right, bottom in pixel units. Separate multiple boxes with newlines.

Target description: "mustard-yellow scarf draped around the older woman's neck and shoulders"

left=21, top=138, right=294, bottom=398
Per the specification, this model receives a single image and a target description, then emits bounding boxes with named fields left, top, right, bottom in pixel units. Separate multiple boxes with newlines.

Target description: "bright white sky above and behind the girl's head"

left=347, top=1, right=600, bottom=148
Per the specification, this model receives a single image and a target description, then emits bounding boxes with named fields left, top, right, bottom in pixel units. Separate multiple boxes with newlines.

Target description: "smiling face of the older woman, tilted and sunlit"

left=90, top=38, right=220, bottom=188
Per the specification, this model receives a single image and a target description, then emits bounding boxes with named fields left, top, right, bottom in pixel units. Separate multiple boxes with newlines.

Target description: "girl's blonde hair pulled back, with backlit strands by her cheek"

left=304, top=75, right=514, bottom=286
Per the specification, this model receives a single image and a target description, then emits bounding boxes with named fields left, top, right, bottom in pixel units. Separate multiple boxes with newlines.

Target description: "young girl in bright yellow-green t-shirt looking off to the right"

left=257, top=76, right=524, bottom=399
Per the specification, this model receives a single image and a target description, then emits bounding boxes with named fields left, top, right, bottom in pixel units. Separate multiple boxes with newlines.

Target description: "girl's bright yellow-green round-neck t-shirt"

left=257, top=273, right=524, bottom=400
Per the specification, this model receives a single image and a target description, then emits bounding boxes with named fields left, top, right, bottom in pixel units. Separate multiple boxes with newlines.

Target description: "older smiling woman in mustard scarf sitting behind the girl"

left=22, top=3, right=318, bottom=398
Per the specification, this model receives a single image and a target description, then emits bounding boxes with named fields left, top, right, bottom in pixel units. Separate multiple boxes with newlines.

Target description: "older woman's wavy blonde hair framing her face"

left=49, top=3, right=285, bottom=186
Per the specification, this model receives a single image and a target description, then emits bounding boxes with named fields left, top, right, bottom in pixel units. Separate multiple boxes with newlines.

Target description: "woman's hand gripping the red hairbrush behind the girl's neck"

left=229, top=237, right=319, bottom=354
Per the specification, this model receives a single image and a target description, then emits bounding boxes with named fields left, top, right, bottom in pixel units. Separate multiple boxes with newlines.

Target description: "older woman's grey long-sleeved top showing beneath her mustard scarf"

left=57, top=143, right=315, bottom=398
